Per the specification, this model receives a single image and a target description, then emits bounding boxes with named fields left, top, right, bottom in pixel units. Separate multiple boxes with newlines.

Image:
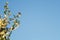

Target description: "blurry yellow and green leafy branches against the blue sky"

left=0, top=2, right=21, bottom=40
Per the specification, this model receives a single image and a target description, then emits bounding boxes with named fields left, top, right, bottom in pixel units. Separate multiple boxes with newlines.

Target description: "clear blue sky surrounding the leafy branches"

left=0, top=0, right=60, bottom=40
